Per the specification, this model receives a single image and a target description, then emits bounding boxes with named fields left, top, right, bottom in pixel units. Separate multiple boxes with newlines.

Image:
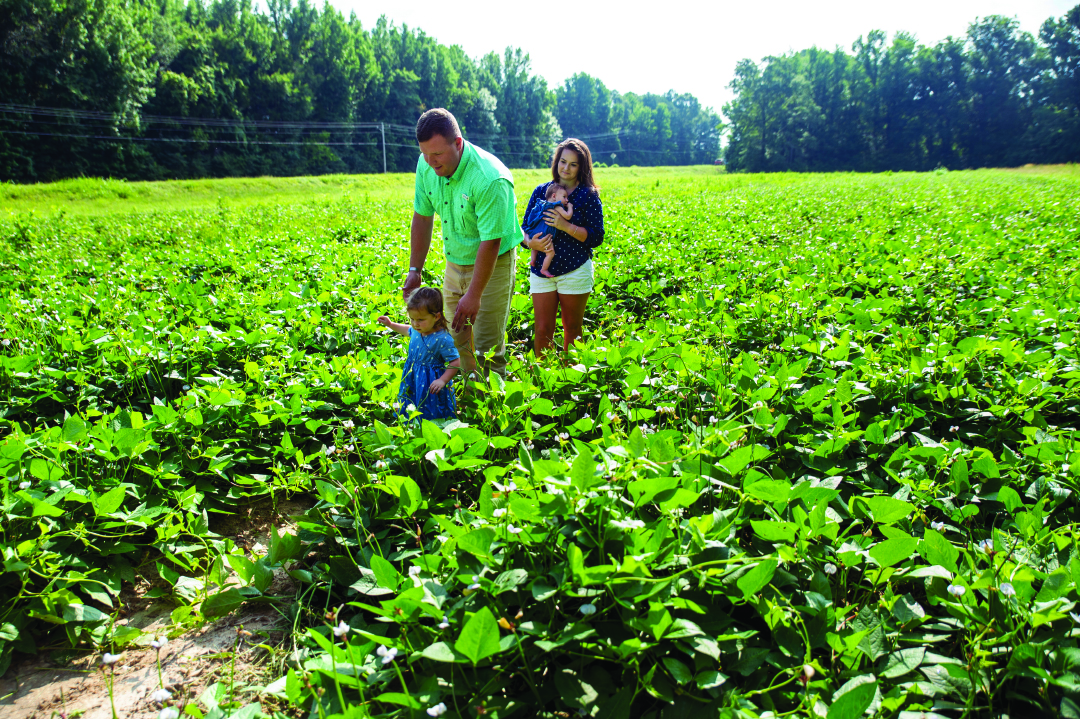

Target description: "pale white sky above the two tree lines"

left=315, top=0, right=1080, bottom=112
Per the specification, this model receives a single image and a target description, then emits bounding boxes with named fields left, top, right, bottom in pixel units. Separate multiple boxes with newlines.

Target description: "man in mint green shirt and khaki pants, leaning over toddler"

left=402, top=108, right=522, bottom=375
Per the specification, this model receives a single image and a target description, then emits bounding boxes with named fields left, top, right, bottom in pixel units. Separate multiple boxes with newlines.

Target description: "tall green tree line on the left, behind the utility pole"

left=0, top=0, right=720, bottom=181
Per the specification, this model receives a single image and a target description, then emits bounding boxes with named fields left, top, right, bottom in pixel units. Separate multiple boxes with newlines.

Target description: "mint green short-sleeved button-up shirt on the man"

left=413, top=140, right=522, bottom=264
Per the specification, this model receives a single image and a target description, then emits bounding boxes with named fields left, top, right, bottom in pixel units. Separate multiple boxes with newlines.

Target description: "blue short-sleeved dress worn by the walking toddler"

left=397, top=327, right=458, bottom=419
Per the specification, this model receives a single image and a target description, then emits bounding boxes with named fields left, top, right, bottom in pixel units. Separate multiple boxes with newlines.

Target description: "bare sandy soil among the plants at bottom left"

left=0, top=498, right=312, bottom=719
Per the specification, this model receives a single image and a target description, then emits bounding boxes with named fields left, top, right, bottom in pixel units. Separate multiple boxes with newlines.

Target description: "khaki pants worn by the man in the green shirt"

left=443, top=247, right=517, bottom=376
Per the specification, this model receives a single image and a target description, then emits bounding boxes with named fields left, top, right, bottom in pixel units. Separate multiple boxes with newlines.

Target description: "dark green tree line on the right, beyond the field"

left=724, top=5, right=1080, bottom=172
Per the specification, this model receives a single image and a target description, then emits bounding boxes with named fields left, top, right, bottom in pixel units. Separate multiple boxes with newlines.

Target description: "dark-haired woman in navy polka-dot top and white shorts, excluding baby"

left=522, top=137, right=604, bottom=355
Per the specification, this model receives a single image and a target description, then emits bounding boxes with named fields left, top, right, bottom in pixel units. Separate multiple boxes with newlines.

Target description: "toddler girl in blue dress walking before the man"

left=378, top=287, right=460, bottom=419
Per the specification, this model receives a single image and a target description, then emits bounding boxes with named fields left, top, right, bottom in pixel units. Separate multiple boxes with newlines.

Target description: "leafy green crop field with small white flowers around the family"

left=0, top=167, right=1080, bottom=719
